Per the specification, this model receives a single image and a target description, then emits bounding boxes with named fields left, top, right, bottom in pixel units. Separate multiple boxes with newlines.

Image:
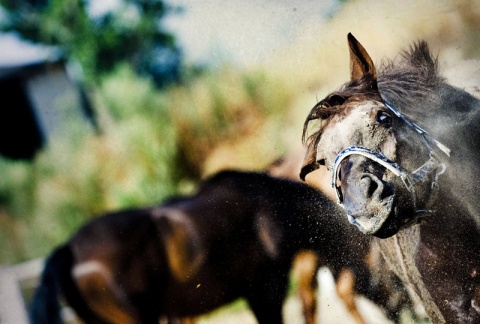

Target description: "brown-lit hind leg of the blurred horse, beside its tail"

left=72, top=261, right=139, bottom=324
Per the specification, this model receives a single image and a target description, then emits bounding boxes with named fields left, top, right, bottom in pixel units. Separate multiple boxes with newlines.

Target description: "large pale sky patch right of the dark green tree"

left=161, top=0, right=338, bottom=65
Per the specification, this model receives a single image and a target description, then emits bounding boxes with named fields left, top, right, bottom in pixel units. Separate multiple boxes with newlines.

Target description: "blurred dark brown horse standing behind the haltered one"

left=30, top=171, right=410, bottom=323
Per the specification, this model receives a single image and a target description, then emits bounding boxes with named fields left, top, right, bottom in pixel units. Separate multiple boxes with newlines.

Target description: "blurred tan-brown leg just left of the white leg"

left=293, top=251, right=320, bottom=324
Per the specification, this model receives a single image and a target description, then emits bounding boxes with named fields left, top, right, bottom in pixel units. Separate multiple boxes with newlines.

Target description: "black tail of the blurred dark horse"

left=30, top=245, right=101, bottom=324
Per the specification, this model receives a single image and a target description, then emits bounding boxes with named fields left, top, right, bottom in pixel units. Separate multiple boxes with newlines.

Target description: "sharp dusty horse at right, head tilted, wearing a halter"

left=300, top=33, right=480, bottom=323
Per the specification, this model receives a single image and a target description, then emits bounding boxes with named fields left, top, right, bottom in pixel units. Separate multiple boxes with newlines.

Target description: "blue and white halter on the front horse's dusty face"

left=331, top=100, right=450, bottom=214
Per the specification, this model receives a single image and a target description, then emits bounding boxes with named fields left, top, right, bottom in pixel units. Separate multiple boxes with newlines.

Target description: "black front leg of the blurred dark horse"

left=246, top=268, right=288, bottom=324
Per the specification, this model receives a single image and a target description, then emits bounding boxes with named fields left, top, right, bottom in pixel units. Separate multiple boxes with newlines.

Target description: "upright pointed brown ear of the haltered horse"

left=348, top=33, right=377, bottom=81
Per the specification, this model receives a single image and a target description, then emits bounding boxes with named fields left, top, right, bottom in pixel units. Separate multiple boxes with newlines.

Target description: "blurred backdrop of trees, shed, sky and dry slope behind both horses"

left=0, top=0, right=480, bottom=320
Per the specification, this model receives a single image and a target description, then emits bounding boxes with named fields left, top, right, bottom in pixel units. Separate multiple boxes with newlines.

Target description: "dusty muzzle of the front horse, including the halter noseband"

left=331, top=146, right=446, bottom=237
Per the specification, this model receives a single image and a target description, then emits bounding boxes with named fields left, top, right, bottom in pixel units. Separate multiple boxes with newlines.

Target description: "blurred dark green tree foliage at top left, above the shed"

left=0, top=0, right=181, bottom=86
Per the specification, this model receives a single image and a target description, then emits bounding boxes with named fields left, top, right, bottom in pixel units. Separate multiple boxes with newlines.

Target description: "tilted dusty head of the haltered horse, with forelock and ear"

left=300, top=34, right=449, bottom=238
